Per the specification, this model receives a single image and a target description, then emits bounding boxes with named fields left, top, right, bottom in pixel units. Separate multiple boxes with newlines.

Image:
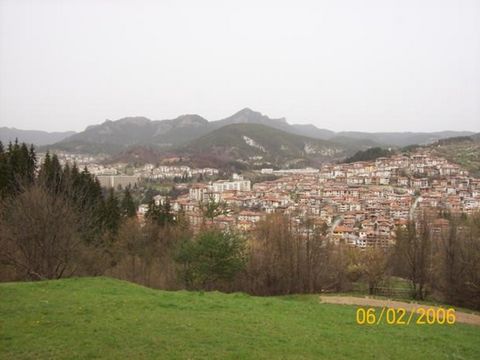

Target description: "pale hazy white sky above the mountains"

left=0, top=0, right=480, bottom=131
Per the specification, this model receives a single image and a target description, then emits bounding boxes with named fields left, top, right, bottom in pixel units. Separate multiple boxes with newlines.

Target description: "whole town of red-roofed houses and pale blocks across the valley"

left=47, top=147, right=480, bottom=248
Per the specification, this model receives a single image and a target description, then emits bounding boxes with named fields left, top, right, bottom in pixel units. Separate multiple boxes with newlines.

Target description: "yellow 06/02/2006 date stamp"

left=356, top=306, right=456, bottom=325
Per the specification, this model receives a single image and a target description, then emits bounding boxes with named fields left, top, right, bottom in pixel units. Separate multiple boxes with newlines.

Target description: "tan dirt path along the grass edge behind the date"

left=320, top=296, right=480, bottom=326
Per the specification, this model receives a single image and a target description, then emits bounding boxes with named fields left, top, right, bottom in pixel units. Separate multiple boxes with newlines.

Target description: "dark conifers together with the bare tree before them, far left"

left=0, top=142, right=136, bottom=280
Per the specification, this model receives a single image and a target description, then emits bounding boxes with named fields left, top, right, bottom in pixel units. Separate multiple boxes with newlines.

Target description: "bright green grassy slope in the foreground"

left=0, top=278, right=480, bottom=359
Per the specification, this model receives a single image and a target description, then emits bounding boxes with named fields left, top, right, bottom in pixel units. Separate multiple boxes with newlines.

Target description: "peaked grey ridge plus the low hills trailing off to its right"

left=51, top=108, right=473, bottom=153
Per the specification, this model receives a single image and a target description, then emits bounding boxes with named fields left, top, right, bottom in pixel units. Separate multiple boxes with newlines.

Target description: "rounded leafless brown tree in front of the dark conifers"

left=0, top=185, right=82, bottom=280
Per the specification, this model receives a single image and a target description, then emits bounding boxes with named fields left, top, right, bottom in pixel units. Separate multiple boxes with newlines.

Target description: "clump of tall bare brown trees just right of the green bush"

left=240, top=214, right=338, bottom=295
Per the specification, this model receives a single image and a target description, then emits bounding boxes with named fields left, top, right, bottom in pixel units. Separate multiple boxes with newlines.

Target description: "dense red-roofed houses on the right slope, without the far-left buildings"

left=136, top=153, right=480, bottom=248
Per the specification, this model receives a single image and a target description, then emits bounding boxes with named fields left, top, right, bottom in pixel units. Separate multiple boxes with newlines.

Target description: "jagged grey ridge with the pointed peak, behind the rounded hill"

left=51, top=108, right=378, bottom=154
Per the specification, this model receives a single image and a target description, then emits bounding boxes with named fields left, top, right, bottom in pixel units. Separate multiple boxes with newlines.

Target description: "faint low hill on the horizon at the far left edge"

left=0, top=127, right=75, bottom=145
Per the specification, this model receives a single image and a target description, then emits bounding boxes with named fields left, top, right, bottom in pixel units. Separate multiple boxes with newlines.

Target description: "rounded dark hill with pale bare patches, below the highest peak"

left=178, top=123, right=349, bottom=166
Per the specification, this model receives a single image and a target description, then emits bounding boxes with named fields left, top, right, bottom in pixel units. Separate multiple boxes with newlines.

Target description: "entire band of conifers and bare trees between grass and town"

left=0, top=143, right=480, bottom=309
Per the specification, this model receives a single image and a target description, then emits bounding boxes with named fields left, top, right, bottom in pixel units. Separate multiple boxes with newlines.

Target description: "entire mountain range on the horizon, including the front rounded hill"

left=0, top=108, right=474, bottom=166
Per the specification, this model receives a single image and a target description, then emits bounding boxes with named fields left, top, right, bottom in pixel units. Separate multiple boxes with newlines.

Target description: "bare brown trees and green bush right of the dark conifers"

left=108, top=213, right=480, bottom=309
